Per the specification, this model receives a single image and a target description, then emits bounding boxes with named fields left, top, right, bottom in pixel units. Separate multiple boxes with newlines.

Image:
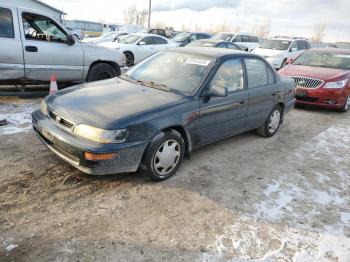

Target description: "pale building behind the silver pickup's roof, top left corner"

left=0, top=0, right=66, bottom=23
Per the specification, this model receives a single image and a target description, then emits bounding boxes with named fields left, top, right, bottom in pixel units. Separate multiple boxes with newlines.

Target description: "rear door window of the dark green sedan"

left=245, top=58, right=268, bottom=88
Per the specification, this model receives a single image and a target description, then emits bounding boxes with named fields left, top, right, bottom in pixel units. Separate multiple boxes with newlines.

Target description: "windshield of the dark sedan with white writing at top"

left=126, top=52, right=213, bottom=94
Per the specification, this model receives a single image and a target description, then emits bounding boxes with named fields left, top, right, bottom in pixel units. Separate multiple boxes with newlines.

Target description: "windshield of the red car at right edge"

left=292, top=51, right=350, bottom=70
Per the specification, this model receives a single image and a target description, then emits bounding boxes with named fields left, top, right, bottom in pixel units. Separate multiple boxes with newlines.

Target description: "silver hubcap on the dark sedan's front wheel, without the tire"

left=153, top=139, right=181, bottom=176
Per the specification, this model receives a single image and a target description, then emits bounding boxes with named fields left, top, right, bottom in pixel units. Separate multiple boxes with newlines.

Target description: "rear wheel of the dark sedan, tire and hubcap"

left=256, top=105, right=283, bottom=137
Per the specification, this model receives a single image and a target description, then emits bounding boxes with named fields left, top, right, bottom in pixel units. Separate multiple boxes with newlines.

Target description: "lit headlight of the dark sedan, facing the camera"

left=74, top=125, right=128, bottom=144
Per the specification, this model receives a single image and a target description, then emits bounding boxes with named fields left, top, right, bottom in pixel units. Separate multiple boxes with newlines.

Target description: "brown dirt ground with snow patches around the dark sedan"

left=0, top=98, right=350, bottom=261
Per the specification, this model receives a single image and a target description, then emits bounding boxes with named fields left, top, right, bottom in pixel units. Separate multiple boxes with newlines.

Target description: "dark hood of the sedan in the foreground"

left=47, top=78, right=184, bottom=129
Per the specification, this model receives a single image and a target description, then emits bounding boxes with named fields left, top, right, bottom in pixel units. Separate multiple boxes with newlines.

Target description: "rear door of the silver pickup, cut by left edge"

left=0, top=6, right=24, bottom=80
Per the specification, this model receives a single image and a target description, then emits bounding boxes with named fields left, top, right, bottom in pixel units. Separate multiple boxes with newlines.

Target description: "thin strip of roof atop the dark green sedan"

left=166, top=47, right=246, bottom=58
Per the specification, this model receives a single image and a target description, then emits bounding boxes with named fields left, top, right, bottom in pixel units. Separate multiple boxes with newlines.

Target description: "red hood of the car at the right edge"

left=279, top=64, right=349, bottom=81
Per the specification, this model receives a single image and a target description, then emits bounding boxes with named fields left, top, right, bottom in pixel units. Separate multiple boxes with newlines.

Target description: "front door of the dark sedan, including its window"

left=198, top=58, right=248, bottom=145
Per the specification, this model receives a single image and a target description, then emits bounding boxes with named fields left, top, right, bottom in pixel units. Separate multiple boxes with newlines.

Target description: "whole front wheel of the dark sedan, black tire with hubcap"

left=140, top=129, right=185, bottom=181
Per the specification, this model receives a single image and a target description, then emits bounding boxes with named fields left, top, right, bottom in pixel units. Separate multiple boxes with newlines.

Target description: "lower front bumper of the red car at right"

left=295, top=88, right=347, bottom=109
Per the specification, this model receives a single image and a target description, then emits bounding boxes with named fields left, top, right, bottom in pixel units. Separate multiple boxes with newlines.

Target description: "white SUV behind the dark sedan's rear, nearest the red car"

left=252, top=37, right=311, bottom=70
